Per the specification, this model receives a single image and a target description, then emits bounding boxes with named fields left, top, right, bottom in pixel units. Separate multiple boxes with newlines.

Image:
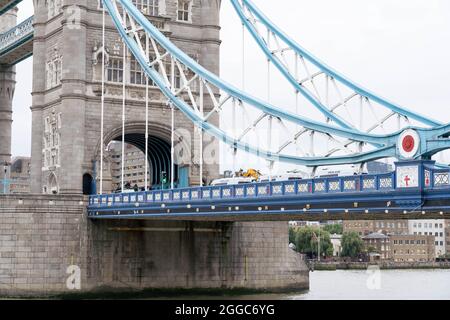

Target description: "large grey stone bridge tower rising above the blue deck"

left=30, top=0, right=220, bottom=194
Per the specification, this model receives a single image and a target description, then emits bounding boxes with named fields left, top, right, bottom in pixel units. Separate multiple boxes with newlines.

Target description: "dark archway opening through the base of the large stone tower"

left=109, top=133, right=179, bottom=190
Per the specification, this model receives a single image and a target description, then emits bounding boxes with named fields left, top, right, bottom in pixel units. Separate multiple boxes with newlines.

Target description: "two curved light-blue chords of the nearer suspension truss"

left=104, top=0, right=449, bottom=166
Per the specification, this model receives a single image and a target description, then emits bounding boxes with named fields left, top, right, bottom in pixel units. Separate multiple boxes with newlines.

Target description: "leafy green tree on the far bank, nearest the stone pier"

left=294, top=227, right=333, bottom=257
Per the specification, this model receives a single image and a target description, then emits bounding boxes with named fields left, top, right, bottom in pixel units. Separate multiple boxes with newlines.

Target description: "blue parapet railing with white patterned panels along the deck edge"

left=89, top=167, right=450, bottom=208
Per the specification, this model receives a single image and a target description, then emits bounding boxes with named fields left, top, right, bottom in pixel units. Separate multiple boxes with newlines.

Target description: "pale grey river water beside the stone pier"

left=154, top=270, right=450, bottom=300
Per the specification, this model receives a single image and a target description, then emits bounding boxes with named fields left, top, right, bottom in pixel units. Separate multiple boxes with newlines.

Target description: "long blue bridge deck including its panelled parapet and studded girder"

left=88, top=162, right=450, bottom=221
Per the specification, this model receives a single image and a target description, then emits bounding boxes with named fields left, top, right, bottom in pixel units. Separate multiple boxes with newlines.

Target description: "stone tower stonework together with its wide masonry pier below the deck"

left=0, top=0, right=309, bottom=296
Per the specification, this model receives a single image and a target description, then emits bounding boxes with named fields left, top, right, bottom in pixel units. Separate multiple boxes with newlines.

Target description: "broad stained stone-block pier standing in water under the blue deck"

left=0, top=195, right=309, bottom=296
